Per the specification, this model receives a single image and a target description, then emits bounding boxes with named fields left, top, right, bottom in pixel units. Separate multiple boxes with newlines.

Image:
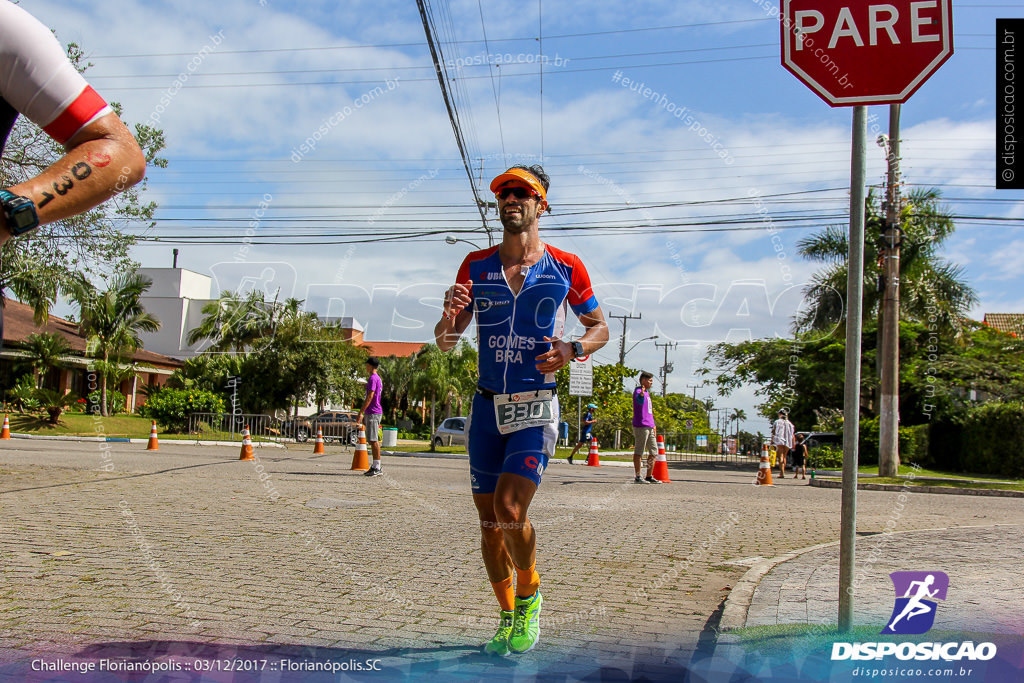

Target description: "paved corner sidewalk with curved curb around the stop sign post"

left=697, top=524, right=1024, bottom=681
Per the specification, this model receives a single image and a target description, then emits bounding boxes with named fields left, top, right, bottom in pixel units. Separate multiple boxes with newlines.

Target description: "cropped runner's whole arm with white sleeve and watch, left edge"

left=0, top=1, right=145, bottom=339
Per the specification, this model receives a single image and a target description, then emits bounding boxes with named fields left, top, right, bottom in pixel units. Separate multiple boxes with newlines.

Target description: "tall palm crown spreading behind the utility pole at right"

left=794, top=188, right=977, bottom=337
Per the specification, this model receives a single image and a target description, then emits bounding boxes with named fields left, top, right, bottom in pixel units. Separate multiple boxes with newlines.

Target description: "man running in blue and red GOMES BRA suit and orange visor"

left=434, top=166, right=608, bottom=656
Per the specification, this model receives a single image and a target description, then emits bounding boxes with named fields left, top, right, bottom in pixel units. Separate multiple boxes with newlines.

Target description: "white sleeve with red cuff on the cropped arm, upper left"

left=0, top=1, right=112, bottom=144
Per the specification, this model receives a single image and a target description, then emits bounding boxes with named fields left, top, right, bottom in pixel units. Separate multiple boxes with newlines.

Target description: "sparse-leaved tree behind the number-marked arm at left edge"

left=0, top=43, right=167, bottom=324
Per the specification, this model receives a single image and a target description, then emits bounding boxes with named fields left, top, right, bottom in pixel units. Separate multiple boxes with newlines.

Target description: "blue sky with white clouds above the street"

left=22, top=0, right=1024, bottom=417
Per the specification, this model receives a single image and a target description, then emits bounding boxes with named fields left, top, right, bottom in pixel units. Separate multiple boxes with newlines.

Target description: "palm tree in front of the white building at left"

left=74, top=272, right=160, bottom=417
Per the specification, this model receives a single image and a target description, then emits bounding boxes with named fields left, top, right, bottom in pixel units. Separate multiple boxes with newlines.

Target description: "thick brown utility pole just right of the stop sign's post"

left=879, top=104, right=902, bottom=477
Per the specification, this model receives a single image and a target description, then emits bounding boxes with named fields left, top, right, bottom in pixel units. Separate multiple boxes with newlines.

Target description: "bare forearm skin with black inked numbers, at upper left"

left=0, top=114, right=145, bottom=244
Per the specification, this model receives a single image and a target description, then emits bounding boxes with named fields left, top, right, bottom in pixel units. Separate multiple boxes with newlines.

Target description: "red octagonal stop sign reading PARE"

left=781, top=0, right=953, bottom=106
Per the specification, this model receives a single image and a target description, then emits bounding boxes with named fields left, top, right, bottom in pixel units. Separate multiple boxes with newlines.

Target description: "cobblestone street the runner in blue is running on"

left=0, top=439, right=1021, bottom=680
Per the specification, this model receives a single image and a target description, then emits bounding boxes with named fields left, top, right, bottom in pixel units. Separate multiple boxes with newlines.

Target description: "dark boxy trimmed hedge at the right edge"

left=959, top=402, right=1024, bottom=477
